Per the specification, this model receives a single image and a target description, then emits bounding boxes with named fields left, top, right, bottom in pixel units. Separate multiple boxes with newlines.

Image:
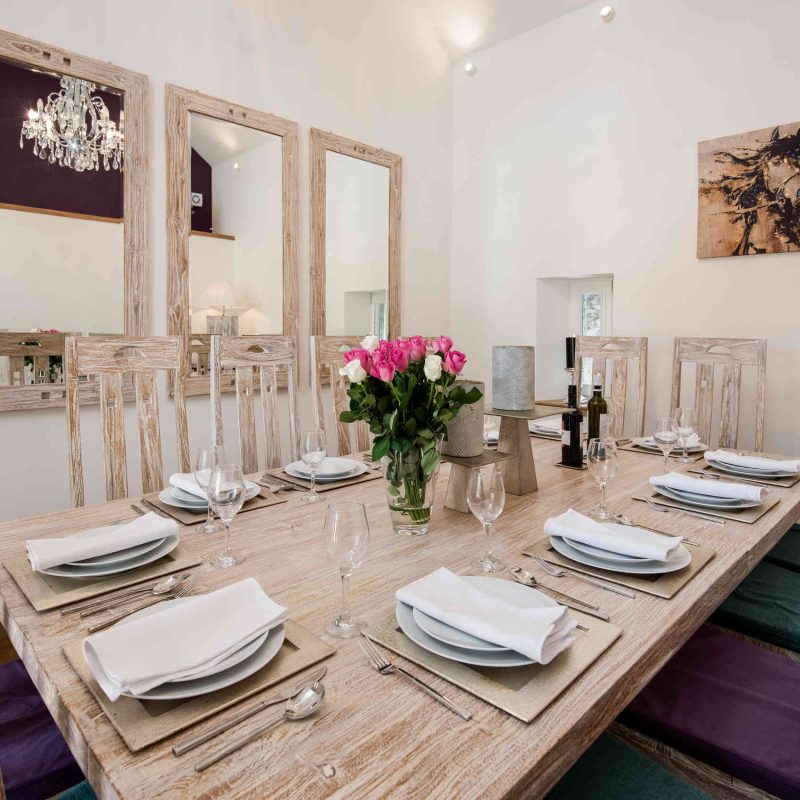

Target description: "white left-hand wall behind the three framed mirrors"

left=0, top=0, right=452, bottom=519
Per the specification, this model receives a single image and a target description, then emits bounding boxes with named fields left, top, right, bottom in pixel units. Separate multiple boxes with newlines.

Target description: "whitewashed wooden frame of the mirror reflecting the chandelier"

left=0, top=30, right=149, bottom=411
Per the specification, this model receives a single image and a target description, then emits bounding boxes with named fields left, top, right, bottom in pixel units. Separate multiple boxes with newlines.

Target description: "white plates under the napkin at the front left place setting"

left=117, top=597, right=285, bottom=700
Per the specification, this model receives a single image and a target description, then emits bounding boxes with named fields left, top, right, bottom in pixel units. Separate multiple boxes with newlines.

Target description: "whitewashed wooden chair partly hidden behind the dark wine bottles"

left=575, top=336, right=647, bottom=436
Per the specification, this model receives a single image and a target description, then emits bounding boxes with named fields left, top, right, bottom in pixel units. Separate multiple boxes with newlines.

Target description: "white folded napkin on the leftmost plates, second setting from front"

left=25, top=511, right=178, bottom=572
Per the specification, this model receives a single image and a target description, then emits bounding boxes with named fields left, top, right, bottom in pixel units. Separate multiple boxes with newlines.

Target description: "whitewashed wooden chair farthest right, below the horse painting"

left=670, top=337, right=767, bottom=451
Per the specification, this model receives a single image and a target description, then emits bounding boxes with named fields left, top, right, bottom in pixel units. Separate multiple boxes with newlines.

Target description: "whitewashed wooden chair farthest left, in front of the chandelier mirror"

left=64, top=336, right=189, bottom=506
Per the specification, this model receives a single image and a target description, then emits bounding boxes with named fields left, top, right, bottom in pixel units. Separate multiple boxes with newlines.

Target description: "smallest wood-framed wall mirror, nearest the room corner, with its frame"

left=311, top=129, right=402, bottom=338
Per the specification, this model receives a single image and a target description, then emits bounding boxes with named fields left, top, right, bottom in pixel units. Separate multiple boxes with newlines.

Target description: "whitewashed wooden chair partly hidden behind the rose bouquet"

left=311, top=336, right=370, bottom=456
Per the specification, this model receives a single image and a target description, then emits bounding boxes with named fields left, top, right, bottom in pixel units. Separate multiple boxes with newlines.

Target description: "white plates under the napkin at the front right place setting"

left=395, top=576, right=558, bottom=667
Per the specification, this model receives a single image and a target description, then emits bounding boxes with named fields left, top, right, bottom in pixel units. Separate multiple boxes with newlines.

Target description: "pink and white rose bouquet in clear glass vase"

left=339, top=336, right=481, bottom=534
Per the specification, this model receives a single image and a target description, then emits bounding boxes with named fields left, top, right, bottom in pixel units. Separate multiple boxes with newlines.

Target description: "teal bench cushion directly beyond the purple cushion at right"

left=711, top=561, right=800, bottom=652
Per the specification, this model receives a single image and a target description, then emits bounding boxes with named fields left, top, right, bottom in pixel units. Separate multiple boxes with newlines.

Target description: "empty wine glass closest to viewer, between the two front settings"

left=325, top=503, right=369, bottom=639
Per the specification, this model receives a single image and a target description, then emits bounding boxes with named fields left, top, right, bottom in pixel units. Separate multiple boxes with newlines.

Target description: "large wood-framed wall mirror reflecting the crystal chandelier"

left=0, top=31, right=148, bottom=410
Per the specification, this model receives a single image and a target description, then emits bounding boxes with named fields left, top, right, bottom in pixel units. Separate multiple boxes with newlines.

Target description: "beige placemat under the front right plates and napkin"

left=364, top=611, right=622, bottom=722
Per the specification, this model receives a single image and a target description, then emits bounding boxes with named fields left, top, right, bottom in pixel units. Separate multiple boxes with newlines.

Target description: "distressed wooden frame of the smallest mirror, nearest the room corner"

left=311, top=128, right=403, bottom=339
